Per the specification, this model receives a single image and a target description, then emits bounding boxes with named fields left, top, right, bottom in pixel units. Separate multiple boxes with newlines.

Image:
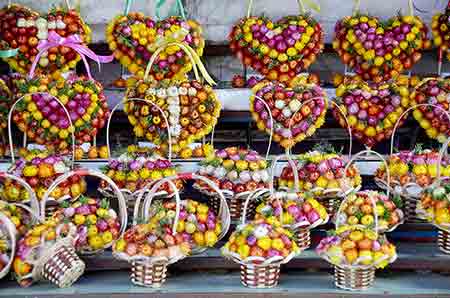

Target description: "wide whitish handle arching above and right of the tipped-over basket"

left=40, top=169, right=127, bottom=235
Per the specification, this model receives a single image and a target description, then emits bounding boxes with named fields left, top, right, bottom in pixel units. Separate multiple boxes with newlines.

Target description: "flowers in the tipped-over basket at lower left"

left=13, top=219, right=84, bottom=287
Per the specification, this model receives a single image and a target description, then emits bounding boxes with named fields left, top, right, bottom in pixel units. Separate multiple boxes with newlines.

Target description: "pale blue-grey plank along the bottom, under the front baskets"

left=0, top=268, right=450, bottom=298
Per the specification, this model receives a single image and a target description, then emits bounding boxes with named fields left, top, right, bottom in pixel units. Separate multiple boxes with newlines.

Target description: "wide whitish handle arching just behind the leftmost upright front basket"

left=144, top=173, right=231, bottom=240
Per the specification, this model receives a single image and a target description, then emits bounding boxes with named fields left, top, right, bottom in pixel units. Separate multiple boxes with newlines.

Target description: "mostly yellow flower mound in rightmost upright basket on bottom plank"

left=316, top=226, right=397, bottom=268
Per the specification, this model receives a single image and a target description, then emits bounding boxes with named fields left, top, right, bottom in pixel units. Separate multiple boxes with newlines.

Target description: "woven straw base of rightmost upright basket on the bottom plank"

left=334, top=266, right=375, bottom=291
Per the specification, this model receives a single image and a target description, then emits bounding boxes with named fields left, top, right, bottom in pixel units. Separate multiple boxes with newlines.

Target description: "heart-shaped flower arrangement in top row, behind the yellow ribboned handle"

left=106, top=12, right=205, bottom=80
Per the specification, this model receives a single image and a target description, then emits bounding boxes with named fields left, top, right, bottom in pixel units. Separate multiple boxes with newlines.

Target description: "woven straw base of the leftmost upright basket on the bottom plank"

left=131, top=262, right=167, bottom=288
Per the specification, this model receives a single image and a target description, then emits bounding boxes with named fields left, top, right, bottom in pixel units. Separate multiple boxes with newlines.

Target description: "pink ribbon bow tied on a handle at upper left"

left=28, top=31, right=114, bottom=79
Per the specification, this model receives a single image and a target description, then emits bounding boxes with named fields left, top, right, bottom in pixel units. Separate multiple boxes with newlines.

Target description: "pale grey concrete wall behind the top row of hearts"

left=0, top=0, right=446, bottom=43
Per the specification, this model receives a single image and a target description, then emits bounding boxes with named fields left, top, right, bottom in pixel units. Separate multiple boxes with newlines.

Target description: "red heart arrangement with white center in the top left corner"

left=0, top=4, right=91, bottom=74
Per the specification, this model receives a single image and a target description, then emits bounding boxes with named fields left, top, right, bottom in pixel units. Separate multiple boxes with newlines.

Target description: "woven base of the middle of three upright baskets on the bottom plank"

left=241, top=265, right=280, bottom=289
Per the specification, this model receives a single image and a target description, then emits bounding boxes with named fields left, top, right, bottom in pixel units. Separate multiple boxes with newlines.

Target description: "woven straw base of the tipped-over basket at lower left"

left=42, top=246, right=85, bottom=288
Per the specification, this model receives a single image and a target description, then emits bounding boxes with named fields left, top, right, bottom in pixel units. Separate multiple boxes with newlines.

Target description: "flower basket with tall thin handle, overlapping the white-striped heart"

left=99, top=98, right=182, bottom=223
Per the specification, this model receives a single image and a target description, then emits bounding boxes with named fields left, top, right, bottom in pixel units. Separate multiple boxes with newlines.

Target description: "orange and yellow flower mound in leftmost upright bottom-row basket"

left=113, top=223, right=192, bottom=262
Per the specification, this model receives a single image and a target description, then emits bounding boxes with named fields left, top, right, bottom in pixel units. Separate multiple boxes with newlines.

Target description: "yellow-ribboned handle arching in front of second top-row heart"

left=144, top=40, right=216, bottom=85
